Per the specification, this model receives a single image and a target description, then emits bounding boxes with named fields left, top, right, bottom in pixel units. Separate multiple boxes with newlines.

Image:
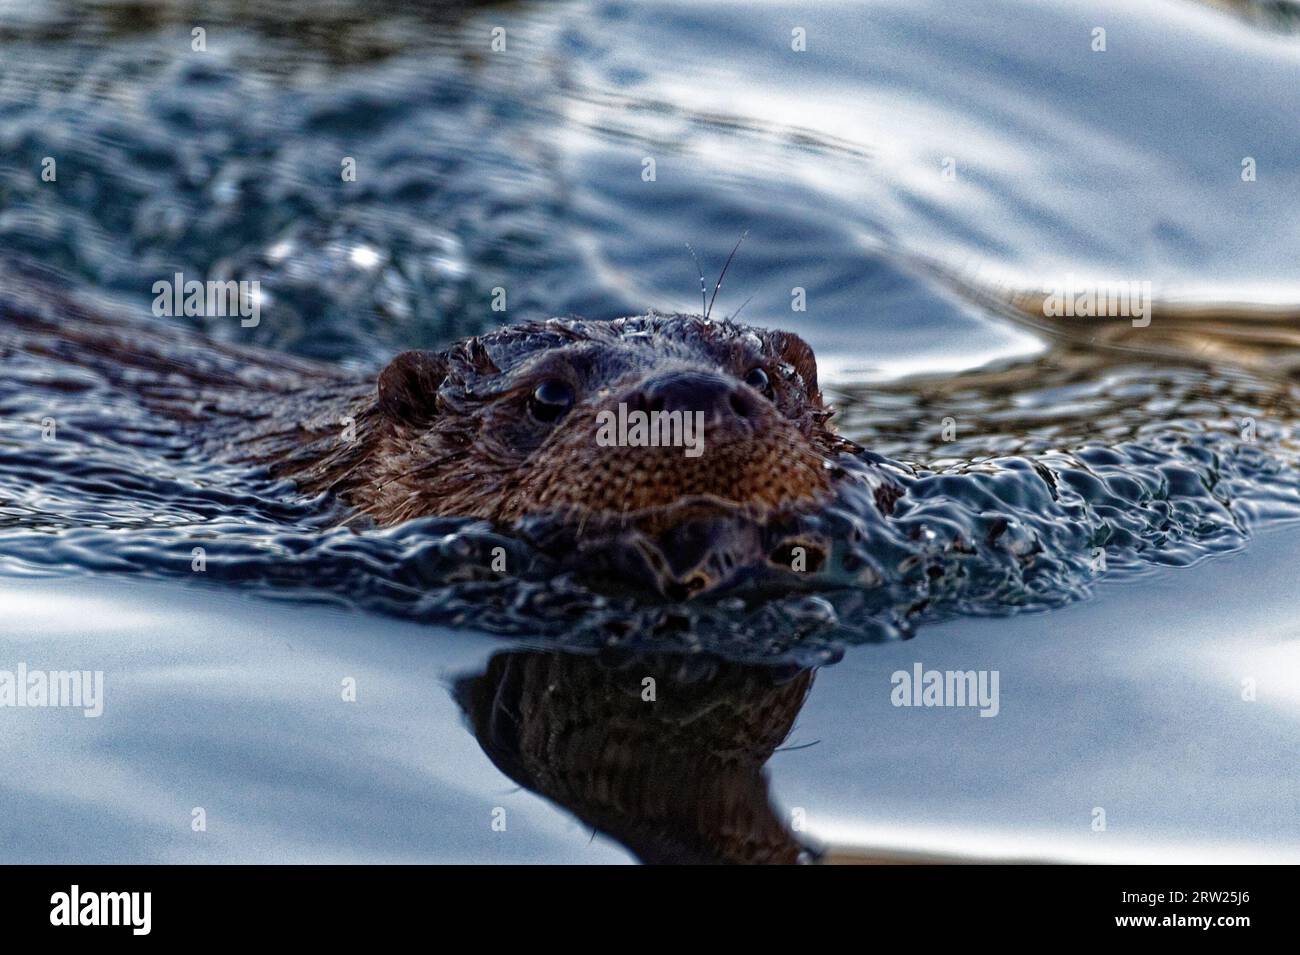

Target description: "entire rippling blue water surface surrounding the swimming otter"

left=0, top=0, right=1300, bottom=861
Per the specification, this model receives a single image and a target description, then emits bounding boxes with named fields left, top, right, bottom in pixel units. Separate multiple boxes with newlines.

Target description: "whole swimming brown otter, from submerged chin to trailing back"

left=0, top=286, right=883, bottom=599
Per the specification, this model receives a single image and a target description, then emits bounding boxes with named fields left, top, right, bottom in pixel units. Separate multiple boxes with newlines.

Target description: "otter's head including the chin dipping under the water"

left=365, top=314, right=846, bottom=594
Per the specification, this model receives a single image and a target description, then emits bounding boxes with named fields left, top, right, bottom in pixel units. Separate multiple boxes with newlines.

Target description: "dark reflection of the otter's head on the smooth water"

left=454, top=650, right=813, bottom=863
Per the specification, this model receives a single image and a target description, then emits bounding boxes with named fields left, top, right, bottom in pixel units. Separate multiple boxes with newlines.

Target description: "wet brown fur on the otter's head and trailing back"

left=0, top=276, right=853, bottom=533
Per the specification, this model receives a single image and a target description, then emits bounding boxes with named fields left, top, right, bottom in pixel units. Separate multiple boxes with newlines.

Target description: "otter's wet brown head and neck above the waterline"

left=220, top=314, right=855, bottom=525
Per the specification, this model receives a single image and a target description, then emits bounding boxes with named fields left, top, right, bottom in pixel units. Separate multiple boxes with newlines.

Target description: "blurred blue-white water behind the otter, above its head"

left=0, top=0, right=1300, bottom=377
